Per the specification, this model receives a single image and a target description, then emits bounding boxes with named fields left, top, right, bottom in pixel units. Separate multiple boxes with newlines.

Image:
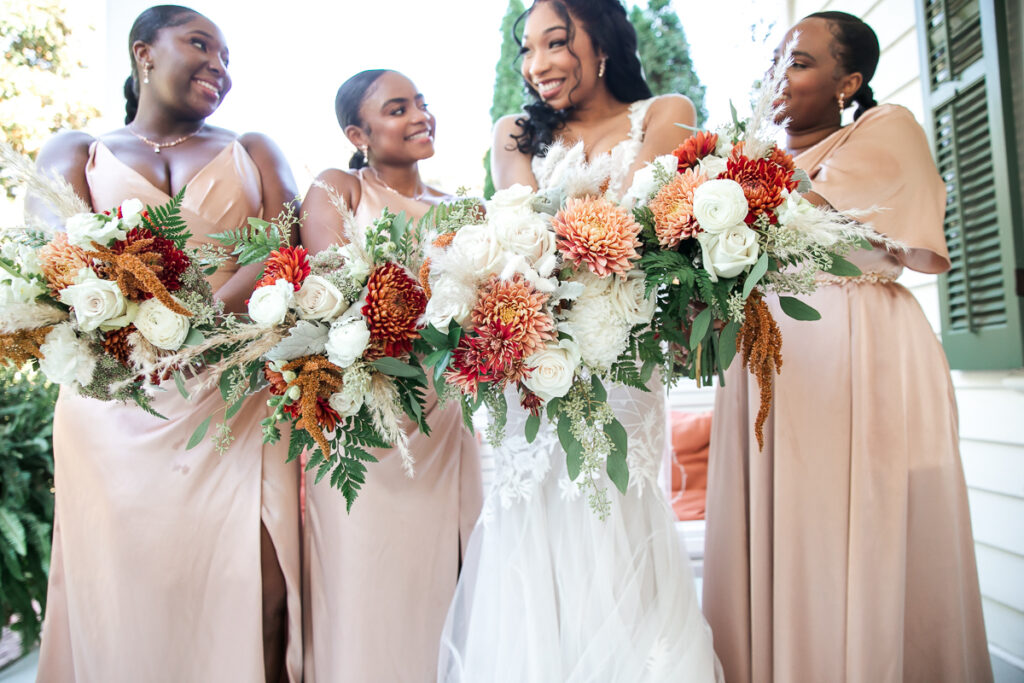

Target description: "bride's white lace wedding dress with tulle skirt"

left=438, top=100, right=721, bottom=683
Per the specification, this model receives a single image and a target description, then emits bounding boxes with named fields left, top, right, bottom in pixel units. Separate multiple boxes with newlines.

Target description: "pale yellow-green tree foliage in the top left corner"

left=0, top=0, right=99, bottom=197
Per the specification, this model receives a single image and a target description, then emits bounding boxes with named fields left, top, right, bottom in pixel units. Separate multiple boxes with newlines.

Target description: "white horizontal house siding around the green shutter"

left=786, top=0, right=1024, bottom=683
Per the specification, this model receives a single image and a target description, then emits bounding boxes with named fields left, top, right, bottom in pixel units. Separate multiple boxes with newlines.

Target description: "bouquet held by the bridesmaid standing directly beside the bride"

left=171, top=203, right=429, bottom=508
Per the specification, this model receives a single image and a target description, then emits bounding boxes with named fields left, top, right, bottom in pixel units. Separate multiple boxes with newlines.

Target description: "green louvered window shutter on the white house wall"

left=918, top=0, right=1024, bottom=370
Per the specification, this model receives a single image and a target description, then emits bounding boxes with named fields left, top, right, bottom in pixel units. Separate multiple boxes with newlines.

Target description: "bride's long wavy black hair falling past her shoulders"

left=512, top=0, right=652, bottom=157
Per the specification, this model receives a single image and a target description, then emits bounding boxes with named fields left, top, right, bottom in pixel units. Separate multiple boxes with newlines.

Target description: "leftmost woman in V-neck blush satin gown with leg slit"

left=30, top=5, right=302, bottom=683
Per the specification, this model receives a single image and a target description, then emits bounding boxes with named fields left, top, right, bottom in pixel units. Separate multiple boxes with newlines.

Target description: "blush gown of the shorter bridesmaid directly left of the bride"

left=304, top=169, right=482, bottom=683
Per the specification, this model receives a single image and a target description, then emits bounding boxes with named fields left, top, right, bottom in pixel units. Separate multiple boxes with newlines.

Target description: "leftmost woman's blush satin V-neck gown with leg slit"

left=38, top=141, right=302, bottom=683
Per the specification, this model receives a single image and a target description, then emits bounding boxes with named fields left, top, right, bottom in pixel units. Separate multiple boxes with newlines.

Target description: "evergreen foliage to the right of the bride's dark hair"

left=630, top=0, right=708, bottom=127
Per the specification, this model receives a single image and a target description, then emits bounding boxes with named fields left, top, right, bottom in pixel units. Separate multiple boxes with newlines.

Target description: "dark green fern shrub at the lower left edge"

left=0, top=368, right=57, bottom=647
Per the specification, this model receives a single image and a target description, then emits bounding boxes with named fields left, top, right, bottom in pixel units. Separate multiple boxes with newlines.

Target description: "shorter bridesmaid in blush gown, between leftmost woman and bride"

left=301, top=70, right=482, bottom=683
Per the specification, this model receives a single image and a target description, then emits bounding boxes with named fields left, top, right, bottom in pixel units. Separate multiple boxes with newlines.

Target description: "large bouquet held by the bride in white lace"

left=421, top=184, right=655, bottom=513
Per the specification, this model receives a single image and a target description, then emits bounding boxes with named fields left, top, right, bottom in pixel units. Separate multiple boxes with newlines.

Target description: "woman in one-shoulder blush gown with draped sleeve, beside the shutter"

left=703, top=12, right=992, bottom=683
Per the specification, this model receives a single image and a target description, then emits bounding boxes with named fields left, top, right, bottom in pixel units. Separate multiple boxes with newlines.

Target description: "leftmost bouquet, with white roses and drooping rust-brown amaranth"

left=0, top=184, right=220, bottom=412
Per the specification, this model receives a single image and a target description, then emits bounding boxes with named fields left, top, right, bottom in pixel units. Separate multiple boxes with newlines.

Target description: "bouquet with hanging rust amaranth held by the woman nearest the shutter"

left=627, top=46, right=899, bottom=445
